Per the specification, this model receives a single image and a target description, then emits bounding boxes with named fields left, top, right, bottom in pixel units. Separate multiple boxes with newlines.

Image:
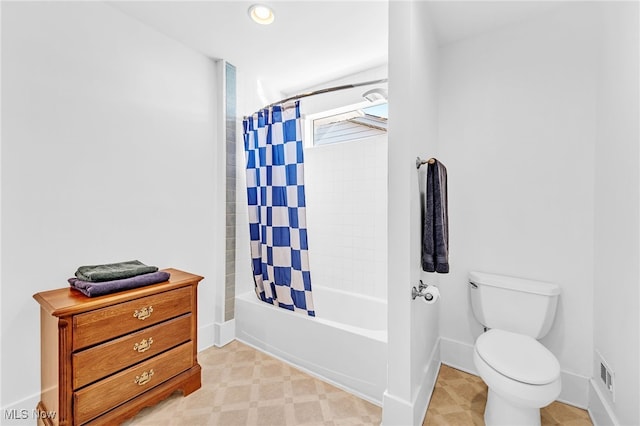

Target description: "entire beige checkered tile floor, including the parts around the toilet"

left=125, top=341, right=591, bottom=426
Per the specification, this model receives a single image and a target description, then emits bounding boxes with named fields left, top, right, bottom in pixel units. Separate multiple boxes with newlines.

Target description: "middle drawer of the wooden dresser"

left=72, top=314, right=192, bottom=390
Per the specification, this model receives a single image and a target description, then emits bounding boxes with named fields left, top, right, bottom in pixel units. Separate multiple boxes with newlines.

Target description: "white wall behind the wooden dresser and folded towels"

left=0, top=2, right=221, bottom=410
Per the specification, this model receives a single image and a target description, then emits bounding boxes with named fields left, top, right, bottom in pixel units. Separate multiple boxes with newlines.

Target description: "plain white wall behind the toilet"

left=439, top=0, right=598, bottom=390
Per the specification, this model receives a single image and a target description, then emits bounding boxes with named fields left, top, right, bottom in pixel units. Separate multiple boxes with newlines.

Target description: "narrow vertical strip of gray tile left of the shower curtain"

left=224, top=63, right=237, bottom=321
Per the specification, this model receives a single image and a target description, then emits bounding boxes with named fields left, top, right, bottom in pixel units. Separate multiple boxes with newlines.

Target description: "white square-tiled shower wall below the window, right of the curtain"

left=305, top=135, right=387, bottom=300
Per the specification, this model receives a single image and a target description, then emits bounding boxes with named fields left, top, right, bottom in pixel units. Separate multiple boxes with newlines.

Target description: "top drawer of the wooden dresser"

left=73, top=287, right=192, bottom=350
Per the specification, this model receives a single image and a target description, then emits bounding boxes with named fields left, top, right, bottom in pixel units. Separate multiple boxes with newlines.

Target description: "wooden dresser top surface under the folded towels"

left=33, top=268, right=203, bottom=317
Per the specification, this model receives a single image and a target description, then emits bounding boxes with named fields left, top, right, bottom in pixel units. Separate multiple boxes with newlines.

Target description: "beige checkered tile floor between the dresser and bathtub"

left=125, top=341, right=382, bottom=426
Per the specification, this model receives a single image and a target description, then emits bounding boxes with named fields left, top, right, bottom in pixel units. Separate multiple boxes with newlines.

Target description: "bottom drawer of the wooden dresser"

left=73, top=342, right=193, bottom=424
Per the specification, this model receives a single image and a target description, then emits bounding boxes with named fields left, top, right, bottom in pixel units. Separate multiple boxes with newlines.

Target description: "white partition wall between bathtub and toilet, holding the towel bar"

left=383, top=2, right=440, bottom=425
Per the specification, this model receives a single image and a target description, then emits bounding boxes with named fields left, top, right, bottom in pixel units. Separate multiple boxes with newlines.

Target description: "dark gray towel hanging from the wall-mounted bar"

left=422, top=160, right=449, bottom=273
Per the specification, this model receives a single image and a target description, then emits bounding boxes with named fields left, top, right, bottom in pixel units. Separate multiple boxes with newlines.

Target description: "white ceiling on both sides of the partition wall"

left=109, top=0, right=560, bottom=95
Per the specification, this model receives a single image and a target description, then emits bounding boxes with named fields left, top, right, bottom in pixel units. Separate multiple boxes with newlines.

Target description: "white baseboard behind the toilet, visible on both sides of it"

left=440, top=337, right=589, bottom=409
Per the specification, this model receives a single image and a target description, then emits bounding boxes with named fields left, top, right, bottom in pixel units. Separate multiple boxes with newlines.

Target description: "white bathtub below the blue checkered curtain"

left=235, top=286, right=387, bottom=406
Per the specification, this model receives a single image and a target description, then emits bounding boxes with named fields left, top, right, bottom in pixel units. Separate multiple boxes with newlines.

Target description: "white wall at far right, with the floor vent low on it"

left=591, top=2, right=640, bottom=425
